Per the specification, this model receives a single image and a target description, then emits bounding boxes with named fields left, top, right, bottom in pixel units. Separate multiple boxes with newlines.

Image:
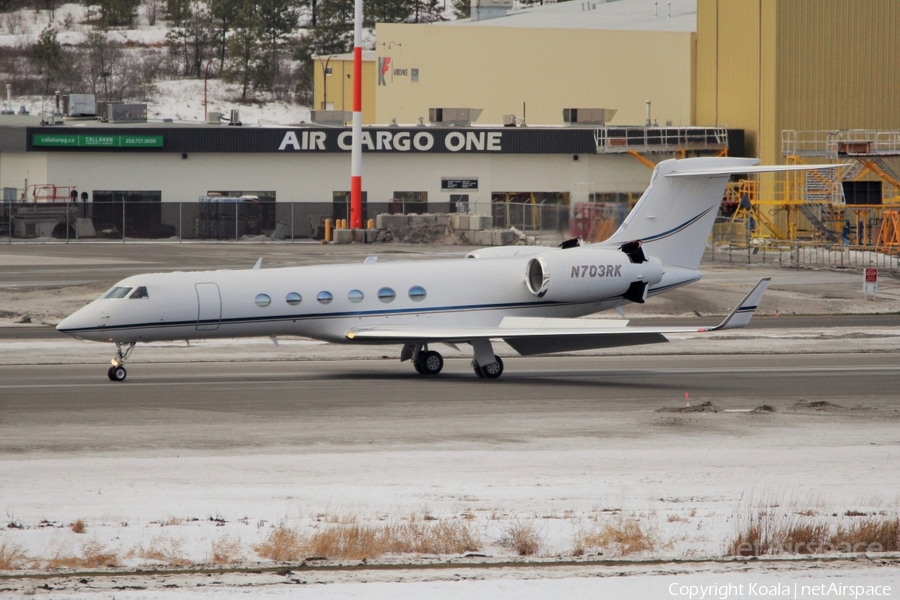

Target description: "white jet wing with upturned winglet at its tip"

left=345, top=277, right=771, bottom=356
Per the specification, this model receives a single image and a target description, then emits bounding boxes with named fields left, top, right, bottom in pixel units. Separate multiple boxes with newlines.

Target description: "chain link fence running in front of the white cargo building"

left=0, top=197, right=569, bottom=243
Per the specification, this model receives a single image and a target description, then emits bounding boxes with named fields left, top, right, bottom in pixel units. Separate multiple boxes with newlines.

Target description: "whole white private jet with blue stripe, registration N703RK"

left=57, top=158, right=834, bottom=381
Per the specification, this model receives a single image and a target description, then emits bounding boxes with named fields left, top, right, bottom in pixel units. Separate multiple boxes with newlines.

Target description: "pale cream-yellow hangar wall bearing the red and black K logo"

left=375, top=23, right=694, bottom=126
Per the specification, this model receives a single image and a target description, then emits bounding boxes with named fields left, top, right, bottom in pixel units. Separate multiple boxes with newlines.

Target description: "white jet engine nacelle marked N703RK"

left=525, top=247, right=663, bottom=302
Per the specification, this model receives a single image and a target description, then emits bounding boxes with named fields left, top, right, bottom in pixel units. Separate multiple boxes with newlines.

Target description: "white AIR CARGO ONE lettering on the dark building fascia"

left=278, top=129, right=504, bottom=152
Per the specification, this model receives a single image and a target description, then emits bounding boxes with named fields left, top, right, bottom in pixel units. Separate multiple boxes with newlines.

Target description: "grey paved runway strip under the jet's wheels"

left=0, top=353, right=900, bottom=455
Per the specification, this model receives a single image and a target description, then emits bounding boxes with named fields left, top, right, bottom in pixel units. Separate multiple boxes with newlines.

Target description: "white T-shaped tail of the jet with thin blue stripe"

left=601, top=157, right=842, bottom=276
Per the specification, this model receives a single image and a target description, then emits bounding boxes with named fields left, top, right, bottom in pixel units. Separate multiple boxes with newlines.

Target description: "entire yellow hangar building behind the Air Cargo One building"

left=316, top=0, right=900, bottom=163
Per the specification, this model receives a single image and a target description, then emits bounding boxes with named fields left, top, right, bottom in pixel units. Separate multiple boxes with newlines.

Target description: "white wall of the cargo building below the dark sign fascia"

left=35, top=152, right=650, bottom=214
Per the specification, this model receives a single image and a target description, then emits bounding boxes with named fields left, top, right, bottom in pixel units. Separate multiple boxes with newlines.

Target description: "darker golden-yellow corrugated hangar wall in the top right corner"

left=696, top=0, right=900, bottom=163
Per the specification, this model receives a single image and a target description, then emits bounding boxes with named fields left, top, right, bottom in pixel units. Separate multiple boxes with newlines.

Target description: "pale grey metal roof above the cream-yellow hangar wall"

left=436, top=0, right=697, bottom=32
